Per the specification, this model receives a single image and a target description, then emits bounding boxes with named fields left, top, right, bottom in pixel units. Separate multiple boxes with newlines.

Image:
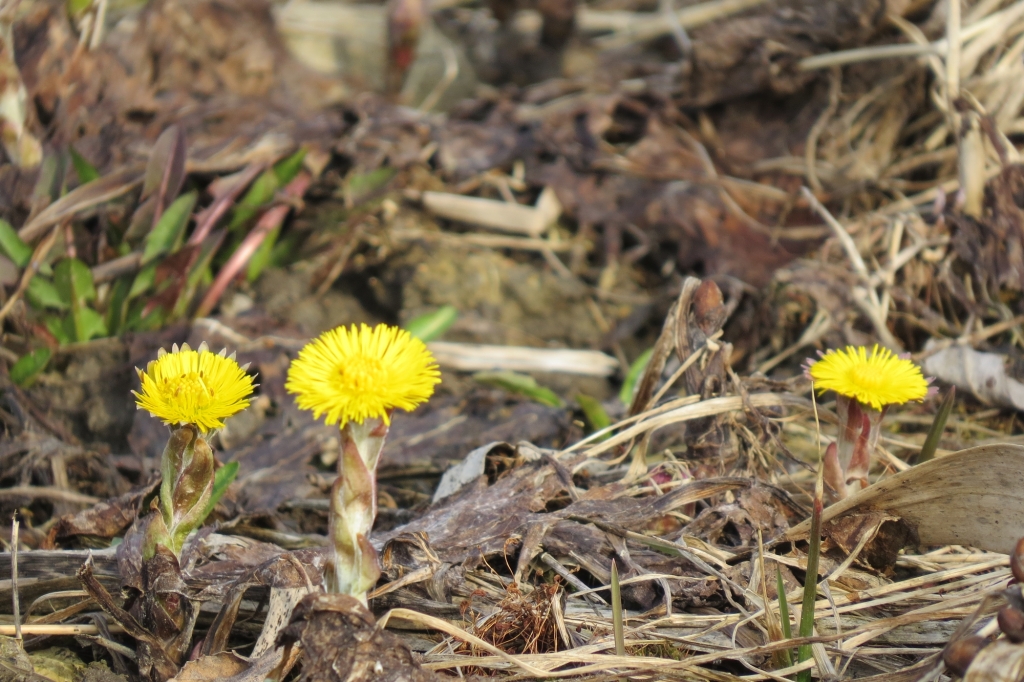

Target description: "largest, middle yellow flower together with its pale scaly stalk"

left=285, top=325, right=440, bottom=604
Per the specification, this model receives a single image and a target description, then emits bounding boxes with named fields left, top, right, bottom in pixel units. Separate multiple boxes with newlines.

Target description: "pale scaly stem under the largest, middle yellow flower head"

left=327, top=418, right=388, bottom=604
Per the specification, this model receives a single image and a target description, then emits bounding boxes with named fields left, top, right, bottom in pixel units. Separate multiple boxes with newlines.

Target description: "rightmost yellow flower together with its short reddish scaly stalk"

left=807, top=345, right=929, bottom=500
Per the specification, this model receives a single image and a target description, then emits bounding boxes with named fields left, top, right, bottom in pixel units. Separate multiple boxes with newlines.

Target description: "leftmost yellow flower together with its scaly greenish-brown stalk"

left=133, top=343, right=254, bottom=558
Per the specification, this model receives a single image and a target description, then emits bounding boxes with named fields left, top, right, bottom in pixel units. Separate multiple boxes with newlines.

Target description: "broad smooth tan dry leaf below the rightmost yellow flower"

left=784, top=443, right=1024, bottom=553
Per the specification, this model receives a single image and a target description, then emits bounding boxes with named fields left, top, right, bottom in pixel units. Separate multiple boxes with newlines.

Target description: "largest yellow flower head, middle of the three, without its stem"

left=285, top=325, right=440, bottom=426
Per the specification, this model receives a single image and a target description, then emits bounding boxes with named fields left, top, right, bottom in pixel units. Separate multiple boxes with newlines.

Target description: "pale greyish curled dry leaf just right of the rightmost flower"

left=922, top=342, right=1024, bottom=410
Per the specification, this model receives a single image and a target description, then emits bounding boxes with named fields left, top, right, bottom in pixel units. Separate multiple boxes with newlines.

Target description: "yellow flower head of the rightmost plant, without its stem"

left=809, top=344, right=928, bottom=410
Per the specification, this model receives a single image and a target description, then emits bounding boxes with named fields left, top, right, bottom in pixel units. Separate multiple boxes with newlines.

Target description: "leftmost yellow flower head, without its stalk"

left=132, top=343, right=254, bottom=433
